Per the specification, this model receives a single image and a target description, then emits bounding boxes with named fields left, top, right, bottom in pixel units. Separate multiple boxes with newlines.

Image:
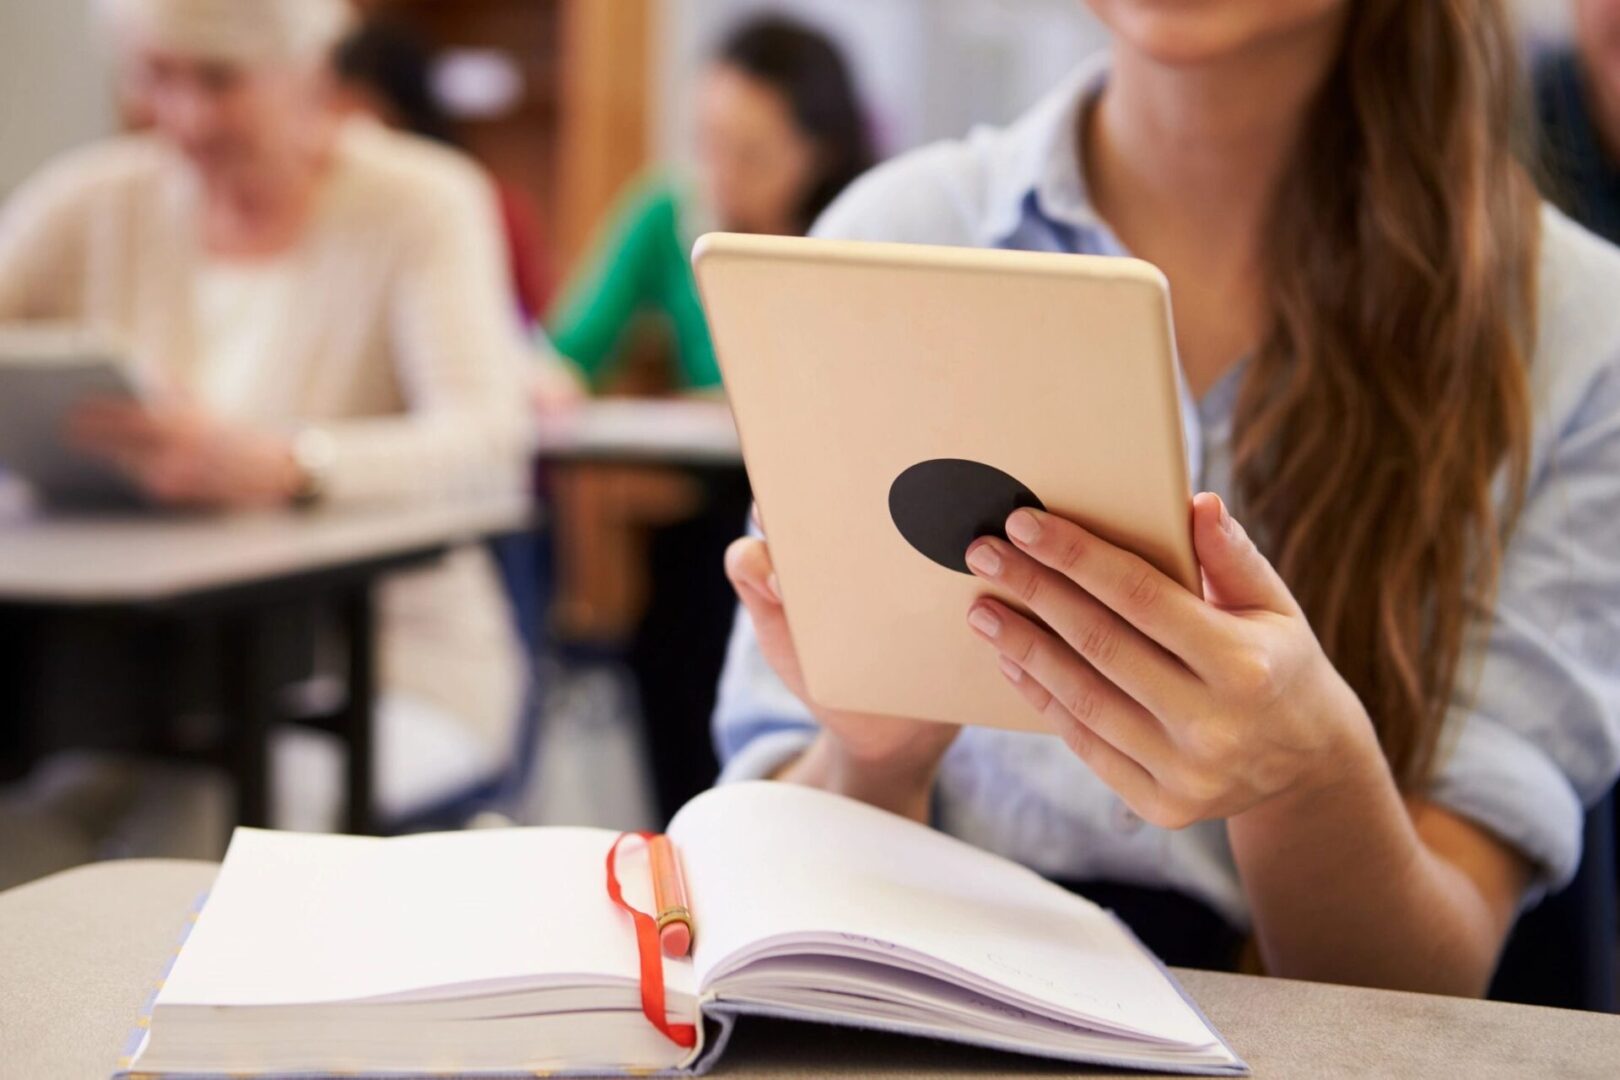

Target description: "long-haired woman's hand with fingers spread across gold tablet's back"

left=967, top=495, right=1379, bottom=829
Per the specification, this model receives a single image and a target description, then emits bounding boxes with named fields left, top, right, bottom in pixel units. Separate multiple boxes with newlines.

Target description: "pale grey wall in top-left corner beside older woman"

left=0, top=0, right=113, bottom=196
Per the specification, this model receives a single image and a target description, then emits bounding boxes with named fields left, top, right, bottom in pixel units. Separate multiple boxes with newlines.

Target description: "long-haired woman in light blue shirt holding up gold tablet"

left=716, top=0, right=1620, bottom=994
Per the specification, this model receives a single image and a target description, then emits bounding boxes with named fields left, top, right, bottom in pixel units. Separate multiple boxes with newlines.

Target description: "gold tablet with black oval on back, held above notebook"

left=693, top=235, right=1200, bottom=730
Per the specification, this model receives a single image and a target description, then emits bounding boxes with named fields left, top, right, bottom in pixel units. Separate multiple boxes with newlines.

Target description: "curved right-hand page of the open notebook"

left=671, top=782, right=1215, bottom=1046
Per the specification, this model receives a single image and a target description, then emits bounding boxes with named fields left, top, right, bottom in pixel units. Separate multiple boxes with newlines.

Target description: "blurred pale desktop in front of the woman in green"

left=539, top=398, right=742, bottom=468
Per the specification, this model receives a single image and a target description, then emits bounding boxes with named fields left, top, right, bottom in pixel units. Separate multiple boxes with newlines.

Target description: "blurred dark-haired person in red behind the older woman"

left=335, top=18, right=552, bottom=325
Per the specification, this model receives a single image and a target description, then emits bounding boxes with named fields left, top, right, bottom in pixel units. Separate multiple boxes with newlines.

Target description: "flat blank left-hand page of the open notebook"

left=157, top=829, right=693, bottom=1007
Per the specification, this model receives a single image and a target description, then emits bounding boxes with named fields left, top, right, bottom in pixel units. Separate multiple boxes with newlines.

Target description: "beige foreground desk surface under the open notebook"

left=0, top=861, right=1620, bottom=1080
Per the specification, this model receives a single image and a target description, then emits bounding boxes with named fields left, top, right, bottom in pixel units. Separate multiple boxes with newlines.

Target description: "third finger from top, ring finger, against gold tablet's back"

left=967, top=599, right=1170, bottom=774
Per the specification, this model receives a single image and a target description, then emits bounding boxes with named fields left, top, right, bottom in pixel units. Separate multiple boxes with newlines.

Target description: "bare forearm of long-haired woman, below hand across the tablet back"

left=1228, top=729, right=1507, bottom=996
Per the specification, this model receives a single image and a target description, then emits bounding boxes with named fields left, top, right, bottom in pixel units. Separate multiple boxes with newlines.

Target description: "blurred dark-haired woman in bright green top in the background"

left=548, top=16, right=875, bottom=392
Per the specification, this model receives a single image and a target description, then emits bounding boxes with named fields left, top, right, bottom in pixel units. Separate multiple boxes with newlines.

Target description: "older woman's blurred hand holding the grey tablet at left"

left=68, top=402, right=303, bottom=507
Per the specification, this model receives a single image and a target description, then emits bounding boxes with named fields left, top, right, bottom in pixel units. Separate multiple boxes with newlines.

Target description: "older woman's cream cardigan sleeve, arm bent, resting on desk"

left=326, top=169, right=533, bottom=500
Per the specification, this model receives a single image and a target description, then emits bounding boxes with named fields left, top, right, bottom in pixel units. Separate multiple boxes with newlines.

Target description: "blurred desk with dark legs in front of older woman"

left=0, top=495, right=533, bottom=832
